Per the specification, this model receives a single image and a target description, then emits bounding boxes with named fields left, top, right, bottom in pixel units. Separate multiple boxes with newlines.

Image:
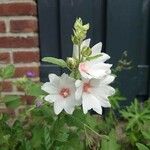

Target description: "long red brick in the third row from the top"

left=0, top=37, right=38, bottom=48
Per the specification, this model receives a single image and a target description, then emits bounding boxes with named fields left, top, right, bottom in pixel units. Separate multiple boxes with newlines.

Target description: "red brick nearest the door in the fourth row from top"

left=13, top=52, right=39, bottom=63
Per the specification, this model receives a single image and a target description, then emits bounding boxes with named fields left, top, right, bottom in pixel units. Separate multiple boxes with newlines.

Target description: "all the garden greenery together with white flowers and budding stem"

left=0, top=18, right=150, bottom=150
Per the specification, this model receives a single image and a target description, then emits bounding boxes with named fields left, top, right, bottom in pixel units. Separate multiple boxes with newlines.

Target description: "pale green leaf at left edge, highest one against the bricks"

left=0, top=64, right=15, bottom=79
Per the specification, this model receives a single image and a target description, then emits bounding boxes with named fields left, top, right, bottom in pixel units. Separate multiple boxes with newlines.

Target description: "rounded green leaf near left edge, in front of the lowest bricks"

left=4, top=95, right=21, bottom=109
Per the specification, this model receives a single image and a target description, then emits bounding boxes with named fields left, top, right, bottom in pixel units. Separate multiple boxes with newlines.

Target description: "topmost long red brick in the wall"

left=0, top=3, right=37, bottom=16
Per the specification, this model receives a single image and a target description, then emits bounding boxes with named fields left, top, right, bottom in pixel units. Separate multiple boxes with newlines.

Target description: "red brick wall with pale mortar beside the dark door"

left=0, top=0, right=39, bottom=94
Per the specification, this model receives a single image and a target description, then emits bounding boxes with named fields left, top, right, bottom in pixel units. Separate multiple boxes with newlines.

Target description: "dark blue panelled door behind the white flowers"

left=38, top=0, right=150, bottom=104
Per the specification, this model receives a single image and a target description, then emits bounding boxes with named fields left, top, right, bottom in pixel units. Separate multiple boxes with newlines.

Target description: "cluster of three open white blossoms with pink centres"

left=42, top=39, right=115, bottom=115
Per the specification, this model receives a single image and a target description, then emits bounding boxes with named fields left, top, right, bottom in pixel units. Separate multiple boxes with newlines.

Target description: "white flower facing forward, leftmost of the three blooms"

left=42, top=73, right=77, bottom=115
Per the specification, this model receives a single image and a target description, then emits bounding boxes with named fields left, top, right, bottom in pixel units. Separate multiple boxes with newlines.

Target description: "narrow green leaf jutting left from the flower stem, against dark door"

left=42, top=57, right=67, bottom=68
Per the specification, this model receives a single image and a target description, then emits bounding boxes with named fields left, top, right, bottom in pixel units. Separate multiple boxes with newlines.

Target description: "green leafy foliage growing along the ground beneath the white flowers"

left=0, top=65, right=150, bottom=150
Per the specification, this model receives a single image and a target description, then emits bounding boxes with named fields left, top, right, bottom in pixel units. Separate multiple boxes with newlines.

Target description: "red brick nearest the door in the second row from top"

left=10, top=20, right=37, bottom=33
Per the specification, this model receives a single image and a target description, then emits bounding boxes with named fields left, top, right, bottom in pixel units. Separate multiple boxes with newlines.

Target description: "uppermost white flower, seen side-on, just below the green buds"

left=73, top=39, right=112, bottom=79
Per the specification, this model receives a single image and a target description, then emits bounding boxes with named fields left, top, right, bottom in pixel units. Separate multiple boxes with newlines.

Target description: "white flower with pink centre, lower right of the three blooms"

left=75, top=75, right=115, bottom=114
